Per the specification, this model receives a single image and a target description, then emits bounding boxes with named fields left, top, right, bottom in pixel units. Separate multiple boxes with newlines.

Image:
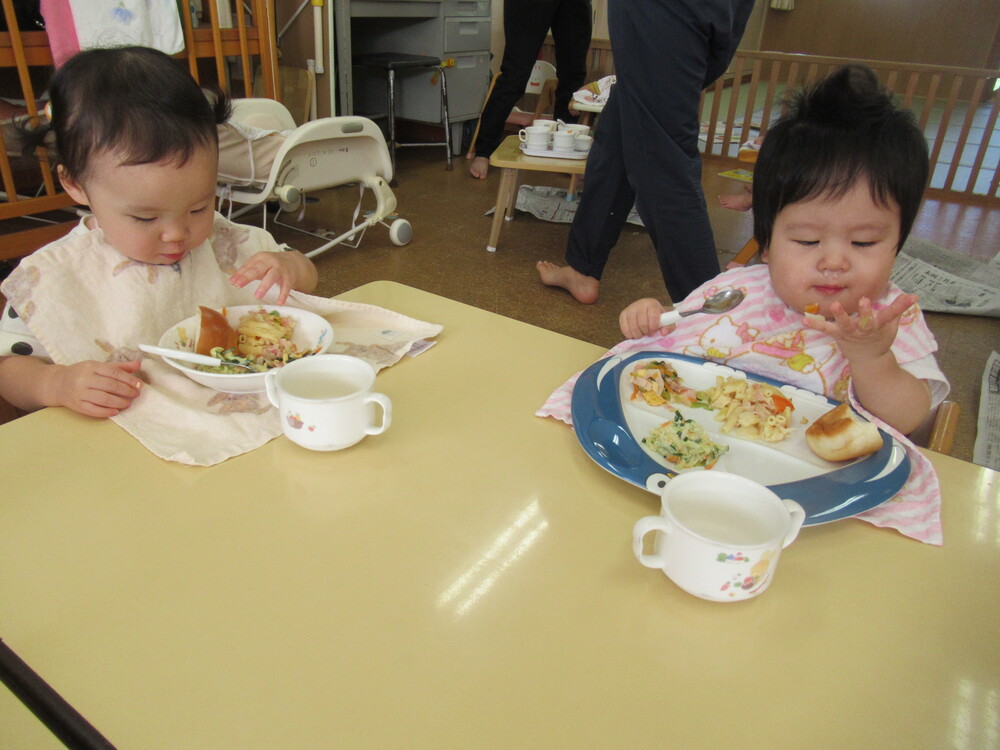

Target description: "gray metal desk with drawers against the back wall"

left=351, top=0, right=490, bottom=154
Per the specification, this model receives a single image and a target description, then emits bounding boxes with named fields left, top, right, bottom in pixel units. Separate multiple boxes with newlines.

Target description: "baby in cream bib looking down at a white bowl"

left=0, top=47, right=317, bottom=417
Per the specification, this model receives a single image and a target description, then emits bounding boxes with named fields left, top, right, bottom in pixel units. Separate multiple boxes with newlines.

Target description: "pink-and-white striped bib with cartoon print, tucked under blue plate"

left=536, top=265, right=943, bottom=545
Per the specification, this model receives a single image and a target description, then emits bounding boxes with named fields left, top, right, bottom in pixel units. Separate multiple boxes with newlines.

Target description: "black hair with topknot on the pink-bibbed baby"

left=753, top=65, right=929, bottom=252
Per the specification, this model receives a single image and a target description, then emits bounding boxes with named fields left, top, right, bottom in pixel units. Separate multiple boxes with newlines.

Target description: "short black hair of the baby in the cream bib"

left=21, top=47, right=230, bottom=182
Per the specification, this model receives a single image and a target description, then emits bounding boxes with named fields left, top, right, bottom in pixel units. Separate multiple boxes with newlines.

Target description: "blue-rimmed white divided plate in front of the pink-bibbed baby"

left=572, top=352, right=910, bottom=526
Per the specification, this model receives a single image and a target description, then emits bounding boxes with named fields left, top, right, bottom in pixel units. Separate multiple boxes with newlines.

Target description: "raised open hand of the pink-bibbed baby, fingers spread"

left=804, top=294, right=918, bottom=363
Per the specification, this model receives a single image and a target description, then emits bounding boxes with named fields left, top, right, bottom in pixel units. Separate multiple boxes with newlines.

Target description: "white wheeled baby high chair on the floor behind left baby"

left=216, top=99, right=413, bottom=258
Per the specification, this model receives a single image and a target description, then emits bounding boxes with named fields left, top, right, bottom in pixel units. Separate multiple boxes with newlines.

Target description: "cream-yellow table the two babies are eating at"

left=0, top=282, right=1000, bottom=750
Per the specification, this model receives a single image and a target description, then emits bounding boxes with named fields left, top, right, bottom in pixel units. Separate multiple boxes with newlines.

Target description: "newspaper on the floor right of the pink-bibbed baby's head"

left=892, top=237, right=1000, bottom=318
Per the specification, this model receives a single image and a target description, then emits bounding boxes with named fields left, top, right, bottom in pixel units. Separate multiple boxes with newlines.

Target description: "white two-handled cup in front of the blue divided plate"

left=632, top=470, right=805, bottom=602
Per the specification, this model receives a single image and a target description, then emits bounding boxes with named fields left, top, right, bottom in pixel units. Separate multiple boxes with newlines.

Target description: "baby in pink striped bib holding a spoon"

left=539, top=65, right=949, bottom=543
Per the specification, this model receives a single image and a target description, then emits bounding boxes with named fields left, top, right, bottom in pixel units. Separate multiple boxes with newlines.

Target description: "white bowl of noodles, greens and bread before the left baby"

left=159, top=304, right=333, bottom=393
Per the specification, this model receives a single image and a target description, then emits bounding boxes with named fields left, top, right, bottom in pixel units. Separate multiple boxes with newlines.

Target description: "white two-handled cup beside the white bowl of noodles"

left=264, top=354, right=392, bottom=451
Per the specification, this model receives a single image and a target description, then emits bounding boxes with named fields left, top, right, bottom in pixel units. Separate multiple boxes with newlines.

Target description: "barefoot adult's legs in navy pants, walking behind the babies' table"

left=539, top=0, right=753, bottom=303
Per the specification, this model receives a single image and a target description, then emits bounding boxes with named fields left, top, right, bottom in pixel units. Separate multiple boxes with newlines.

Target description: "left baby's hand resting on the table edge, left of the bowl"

left=45, top=360, right=142, bottom=417
